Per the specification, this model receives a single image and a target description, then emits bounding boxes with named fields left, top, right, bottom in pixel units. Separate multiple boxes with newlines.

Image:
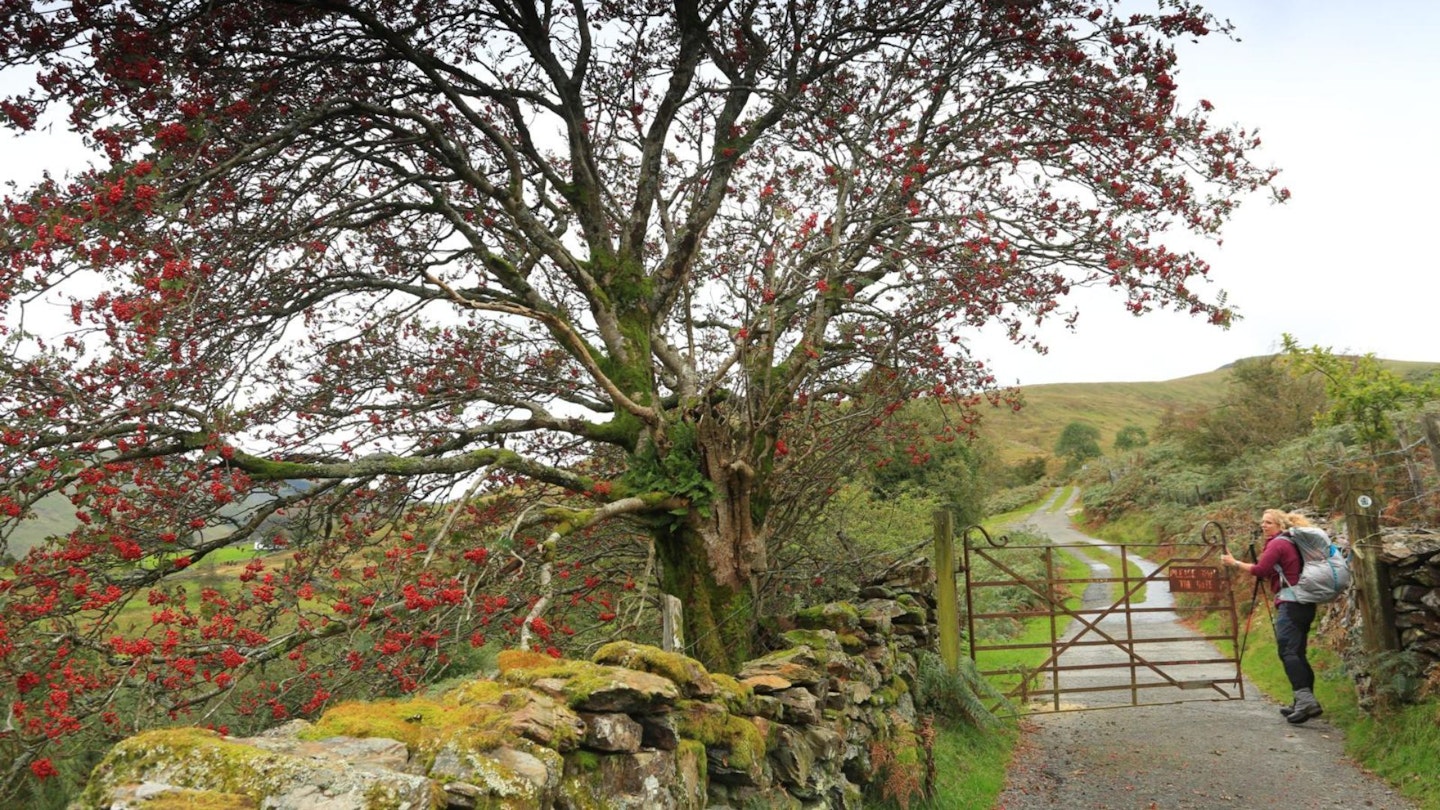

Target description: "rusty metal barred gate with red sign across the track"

left=962, top=523, right=1244, bottom=713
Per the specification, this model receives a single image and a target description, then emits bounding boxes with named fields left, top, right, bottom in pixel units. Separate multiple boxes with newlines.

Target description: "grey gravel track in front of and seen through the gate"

left=995, top=492, right=1414, bottom=810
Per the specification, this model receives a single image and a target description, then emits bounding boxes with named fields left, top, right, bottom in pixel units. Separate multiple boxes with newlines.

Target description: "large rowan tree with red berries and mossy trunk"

left=0, top=0, right=1283, bottom=775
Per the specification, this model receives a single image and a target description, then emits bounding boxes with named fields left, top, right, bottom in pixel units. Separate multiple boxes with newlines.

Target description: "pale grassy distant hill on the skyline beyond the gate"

left=981, top=360, right=1440, bottom=463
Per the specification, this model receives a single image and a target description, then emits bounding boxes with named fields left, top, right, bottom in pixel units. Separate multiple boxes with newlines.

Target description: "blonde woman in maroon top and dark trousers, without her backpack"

left=1220, top=509, right=1325, bottom=724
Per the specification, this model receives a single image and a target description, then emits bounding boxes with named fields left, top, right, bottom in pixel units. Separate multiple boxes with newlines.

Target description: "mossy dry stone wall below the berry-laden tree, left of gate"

left=72, top=561, right=936, bottom=810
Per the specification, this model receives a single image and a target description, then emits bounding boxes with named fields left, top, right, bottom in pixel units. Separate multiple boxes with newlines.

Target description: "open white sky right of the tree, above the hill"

left=972, top=0, right=1440, bottom=385
